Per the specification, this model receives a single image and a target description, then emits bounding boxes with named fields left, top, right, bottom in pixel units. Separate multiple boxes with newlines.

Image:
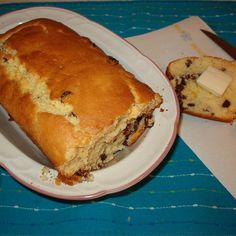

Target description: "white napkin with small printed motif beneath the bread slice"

left=127, top=16, right=236, bottom=198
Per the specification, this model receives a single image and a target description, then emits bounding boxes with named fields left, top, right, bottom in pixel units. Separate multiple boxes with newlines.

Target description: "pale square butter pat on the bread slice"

left=197, top=66, right=232, bottom=96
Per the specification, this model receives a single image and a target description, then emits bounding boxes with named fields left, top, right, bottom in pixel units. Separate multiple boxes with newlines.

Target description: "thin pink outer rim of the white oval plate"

left=0, top=6, right=180, bottom=200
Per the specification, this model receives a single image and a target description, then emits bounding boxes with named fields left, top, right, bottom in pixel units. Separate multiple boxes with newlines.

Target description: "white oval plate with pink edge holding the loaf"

left=0, top=7, right=179, bottom=200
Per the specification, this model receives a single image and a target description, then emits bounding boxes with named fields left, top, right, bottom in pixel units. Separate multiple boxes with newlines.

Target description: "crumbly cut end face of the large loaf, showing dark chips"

left=58, top=96, right=162, bottom=180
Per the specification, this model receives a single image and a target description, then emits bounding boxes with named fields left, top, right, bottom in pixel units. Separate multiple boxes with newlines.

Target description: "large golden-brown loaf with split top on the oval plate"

left=0, top=19, right=162, bottom=181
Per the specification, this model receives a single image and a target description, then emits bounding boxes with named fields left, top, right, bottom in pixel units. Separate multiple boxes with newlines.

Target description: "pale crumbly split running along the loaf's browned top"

left=0, top=46, right=79, bottom=126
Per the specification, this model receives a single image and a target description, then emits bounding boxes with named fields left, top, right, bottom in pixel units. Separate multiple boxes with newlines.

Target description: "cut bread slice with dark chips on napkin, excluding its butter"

left=166, top=56, right=236, bottom=123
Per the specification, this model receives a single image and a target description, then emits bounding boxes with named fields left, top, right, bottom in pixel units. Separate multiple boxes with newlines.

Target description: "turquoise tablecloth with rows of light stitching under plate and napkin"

left=0, top=1, right=236, bottom=235
